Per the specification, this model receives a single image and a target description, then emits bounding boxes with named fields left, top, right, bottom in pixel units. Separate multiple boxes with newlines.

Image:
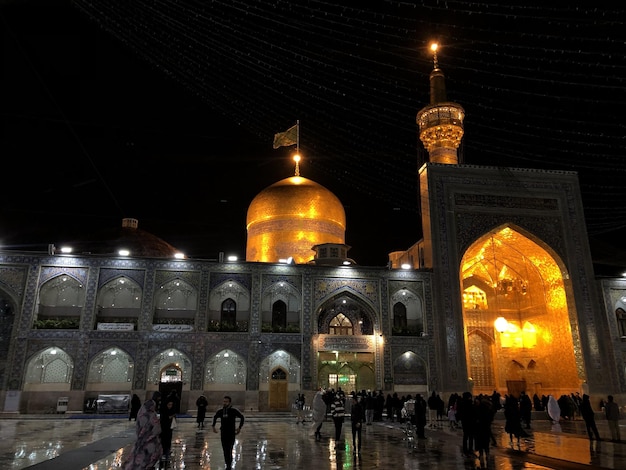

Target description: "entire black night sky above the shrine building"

left=0, top=0, right=626, bottom=266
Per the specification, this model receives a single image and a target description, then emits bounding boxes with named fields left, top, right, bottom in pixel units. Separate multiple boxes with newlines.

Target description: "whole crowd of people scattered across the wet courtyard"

left=123, top=389, right=621, bottom=470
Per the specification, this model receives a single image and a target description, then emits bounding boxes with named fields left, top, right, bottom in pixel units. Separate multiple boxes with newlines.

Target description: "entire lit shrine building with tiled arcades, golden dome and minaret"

left=0, top=61, right=626, bottom=413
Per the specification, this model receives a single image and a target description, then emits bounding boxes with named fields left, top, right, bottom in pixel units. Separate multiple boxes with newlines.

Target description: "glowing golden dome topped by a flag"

left=246, top=176, right=346, bottom=264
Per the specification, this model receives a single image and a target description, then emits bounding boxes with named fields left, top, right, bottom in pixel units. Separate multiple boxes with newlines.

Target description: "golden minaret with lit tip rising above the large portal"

left=416, top=44, right=465, bottom=165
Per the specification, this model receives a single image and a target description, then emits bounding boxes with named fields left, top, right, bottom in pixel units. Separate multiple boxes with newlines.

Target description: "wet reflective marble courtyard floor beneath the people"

left=0, top=413, right=626, bottom=470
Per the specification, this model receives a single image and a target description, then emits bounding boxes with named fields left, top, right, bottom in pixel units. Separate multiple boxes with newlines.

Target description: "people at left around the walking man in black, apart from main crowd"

left=123, top=390, right=244, bottom=470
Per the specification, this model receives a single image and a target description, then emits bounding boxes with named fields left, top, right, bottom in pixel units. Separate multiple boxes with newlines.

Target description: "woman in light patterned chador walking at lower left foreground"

left=122, top=392, right=163, bottom=470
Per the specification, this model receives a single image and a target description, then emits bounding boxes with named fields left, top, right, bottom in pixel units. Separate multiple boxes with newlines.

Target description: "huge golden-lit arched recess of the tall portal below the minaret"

left=460, top=227, right=584, bottom=396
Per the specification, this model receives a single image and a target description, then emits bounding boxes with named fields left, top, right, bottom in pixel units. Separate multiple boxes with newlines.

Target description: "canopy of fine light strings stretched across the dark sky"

left=74, top=0, right=626, bottom=242
